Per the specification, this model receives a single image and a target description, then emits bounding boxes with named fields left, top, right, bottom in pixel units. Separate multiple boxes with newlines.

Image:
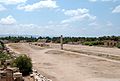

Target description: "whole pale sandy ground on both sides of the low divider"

left=6, top=43, right=120, bottom=81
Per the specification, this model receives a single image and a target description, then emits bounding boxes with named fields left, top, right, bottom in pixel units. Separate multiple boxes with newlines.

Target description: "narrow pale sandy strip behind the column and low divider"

left=50, top=44, right=120, bottom=56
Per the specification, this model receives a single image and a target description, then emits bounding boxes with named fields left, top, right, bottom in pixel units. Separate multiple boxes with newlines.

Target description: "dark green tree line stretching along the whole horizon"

left=0, top=36, right=120, bottom=44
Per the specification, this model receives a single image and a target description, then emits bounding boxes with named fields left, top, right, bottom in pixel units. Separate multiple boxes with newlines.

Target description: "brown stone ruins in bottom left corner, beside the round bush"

left=0, top=60, right=23, bottom=81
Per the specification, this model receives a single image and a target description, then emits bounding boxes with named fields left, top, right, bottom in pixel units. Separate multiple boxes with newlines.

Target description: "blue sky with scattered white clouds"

left=0, top=0, right=120, bottom=37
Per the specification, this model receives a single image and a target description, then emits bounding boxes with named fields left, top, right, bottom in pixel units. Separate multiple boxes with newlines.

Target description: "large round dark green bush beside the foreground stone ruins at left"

left=14, top=55, right=32, bottom=76
